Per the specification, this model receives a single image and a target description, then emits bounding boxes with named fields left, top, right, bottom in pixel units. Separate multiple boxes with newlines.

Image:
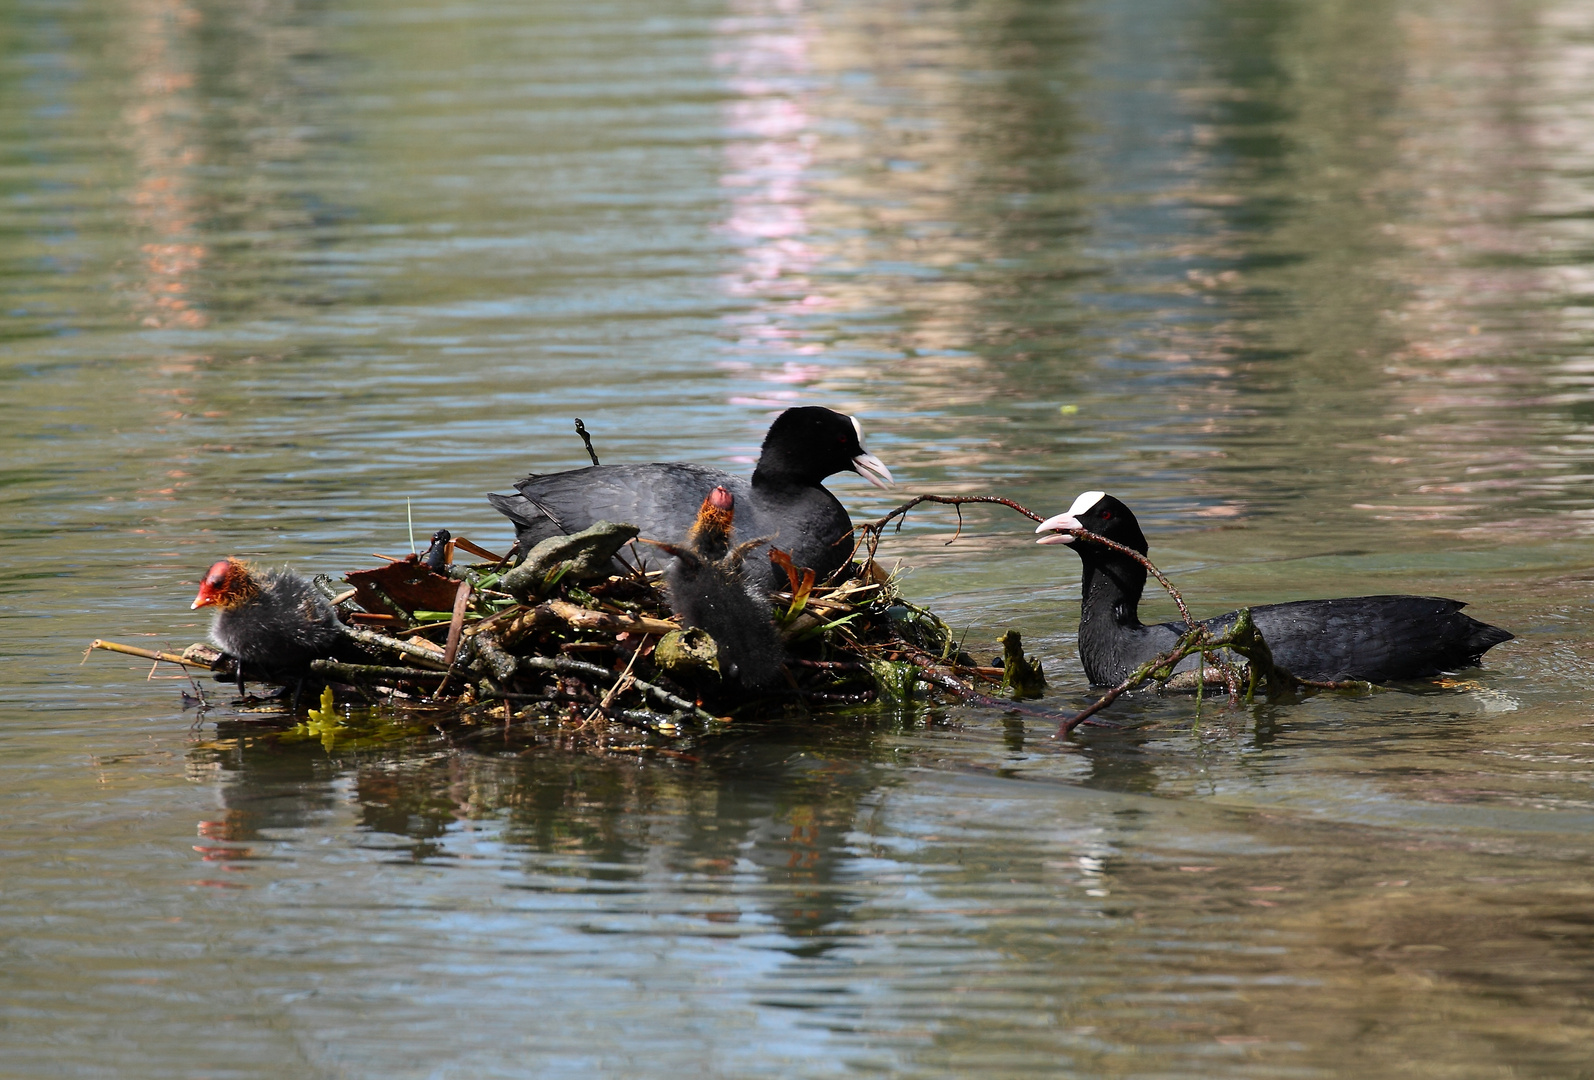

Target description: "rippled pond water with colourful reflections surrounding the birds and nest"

left=0, top=0, right=1594, bottom=1077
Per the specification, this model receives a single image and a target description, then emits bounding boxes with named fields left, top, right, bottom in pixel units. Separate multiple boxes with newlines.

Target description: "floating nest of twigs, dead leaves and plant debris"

left=94, top=512, right=1052, bottom=747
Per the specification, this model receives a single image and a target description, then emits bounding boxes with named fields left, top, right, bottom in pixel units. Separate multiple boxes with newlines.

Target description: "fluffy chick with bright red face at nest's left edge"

left=193, top=559, right=362, bottom=682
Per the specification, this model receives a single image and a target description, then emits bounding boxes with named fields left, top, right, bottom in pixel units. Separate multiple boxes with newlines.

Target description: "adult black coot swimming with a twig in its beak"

left=1036, top=491, right=1513, bottom=687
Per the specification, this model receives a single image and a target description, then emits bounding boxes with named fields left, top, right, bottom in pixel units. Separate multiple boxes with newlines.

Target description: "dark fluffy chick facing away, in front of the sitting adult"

left=657, top=487, right=781, bottom=690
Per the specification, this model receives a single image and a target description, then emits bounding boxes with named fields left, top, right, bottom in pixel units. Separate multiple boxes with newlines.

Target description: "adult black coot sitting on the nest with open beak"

left=488, top=406, right=891, bottom=591
